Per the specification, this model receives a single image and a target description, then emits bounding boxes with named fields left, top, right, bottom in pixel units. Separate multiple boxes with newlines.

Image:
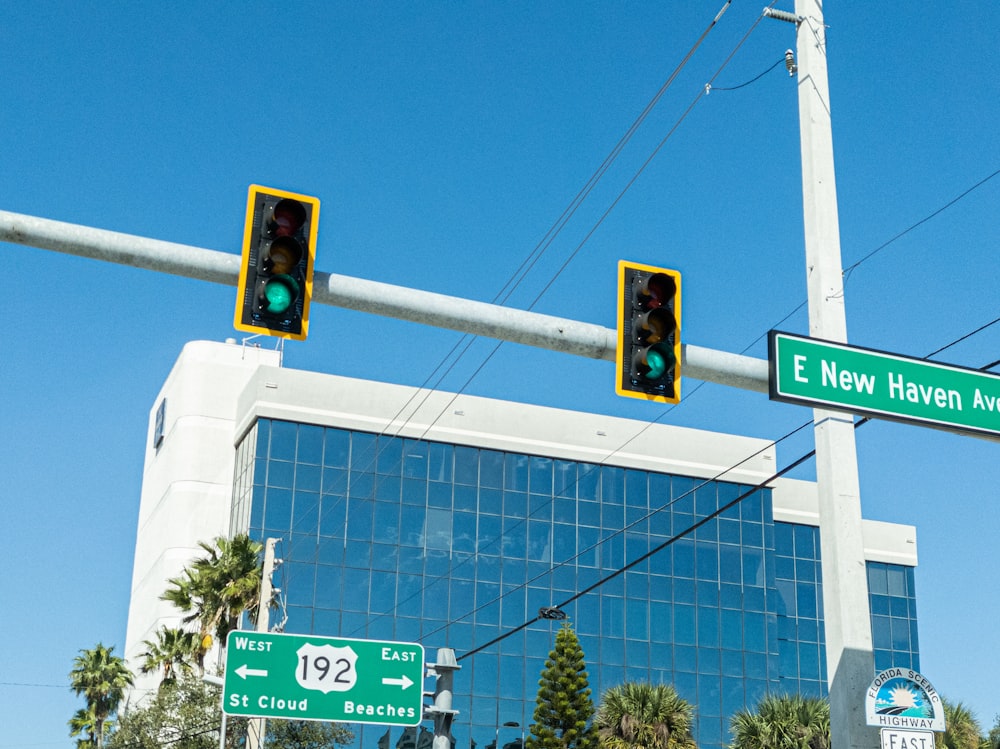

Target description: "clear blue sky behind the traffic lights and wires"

left=0, top=0, right=1000, bottom=749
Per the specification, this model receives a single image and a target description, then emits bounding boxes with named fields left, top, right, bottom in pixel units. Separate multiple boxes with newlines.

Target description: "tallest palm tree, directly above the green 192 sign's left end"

left=160, top=533, right=270, bottom=667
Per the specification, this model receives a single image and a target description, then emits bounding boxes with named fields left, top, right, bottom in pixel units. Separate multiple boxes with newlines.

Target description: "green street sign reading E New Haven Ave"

left=768, top=330, right=1000, bottom=437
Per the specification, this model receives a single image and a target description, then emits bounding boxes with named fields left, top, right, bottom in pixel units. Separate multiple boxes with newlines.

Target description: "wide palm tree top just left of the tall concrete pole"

left=729, top=694, right=830, bottom=749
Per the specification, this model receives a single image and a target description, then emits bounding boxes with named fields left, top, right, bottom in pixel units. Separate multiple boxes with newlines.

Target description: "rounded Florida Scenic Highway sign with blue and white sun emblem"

left=865, top=668, right=944, bottom=731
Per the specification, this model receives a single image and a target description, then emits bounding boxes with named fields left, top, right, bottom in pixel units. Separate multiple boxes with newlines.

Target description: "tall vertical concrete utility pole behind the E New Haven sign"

left=786, top=0, right=880, bottom=749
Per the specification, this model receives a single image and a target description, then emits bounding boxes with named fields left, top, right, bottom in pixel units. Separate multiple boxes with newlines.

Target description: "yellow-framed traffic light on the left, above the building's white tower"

left=233, top=185, right=319, bottom=341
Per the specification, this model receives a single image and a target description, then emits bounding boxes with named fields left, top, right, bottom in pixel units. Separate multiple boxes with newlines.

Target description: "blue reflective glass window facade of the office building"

left=232, top=419, right=919, bottom=747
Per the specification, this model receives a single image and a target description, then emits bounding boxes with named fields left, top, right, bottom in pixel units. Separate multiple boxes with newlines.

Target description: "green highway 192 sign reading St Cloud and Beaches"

left=222, top=632, right=424, bottom=726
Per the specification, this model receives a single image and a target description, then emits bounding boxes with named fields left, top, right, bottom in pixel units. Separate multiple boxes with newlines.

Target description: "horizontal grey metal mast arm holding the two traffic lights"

left=0, top=211, right=768, bottom=393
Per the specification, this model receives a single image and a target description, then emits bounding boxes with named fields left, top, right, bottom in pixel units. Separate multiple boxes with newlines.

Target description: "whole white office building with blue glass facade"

left=125, top=341, right=920, bottom=749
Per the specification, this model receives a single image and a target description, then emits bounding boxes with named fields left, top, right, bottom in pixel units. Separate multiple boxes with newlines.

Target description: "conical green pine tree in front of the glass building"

left=526, top=622, right=597, bottom=749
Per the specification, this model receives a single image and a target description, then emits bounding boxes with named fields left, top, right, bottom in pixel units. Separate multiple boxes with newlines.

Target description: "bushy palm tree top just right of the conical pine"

left=594, top=682, right=697, bottom=749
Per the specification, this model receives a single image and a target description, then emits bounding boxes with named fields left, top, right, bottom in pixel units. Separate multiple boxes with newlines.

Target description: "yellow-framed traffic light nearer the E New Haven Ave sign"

left=615, top=260, right=681, bottom=403
